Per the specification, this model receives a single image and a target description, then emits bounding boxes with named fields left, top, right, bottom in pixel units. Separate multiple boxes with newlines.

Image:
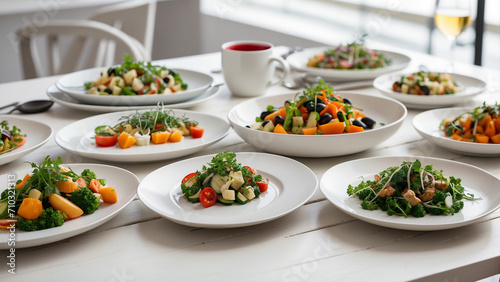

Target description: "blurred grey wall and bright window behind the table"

left=0, top=0, right=500, bottom=83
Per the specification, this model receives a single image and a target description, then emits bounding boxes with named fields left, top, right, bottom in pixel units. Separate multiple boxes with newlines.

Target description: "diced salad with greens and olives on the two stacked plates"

left=85, top=55, right=188, bottom=96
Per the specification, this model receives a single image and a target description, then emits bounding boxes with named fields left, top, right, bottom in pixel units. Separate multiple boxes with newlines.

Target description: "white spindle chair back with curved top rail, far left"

left=17, top=20, right=151, bottom=78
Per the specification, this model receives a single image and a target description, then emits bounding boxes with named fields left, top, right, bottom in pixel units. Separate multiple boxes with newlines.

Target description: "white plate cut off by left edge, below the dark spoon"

left=0, top=115, right=52, bottom=165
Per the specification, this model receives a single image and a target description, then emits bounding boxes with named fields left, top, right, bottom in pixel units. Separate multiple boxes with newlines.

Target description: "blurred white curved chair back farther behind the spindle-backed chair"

left=89, top=0, right=156, bottom=56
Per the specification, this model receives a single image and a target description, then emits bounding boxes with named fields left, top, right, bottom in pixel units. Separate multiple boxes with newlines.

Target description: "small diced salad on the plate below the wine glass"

left=392, top=71, right=458, bottom=95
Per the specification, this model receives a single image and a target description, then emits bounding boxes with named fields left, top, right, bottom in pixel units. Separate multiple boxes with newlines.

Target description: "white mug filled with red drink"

left=222, top=40, right=290, bottom=97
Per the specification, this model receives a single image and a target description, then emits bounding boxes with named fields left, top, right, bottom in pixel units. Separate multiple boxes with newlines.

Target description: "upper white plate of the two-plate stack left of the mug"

left=56, top=67, right=214, bottom=106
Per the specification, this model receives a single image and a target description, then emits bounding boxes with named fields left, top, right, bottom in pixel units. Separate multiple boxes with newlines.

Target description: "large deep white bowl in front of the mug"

left=228, top=92, right=407, bottom=158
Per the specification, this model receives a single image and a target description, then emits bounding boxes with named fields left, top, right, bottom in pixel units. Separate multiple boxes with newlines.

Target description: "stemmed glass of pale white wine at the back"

left=434, top=0, right=471, bottom=72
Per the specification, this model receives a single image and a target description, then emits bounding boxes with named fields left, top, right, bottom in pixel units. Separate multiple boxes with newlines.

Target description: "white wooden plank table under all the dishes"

left=0, top=49, right=500, bottom=281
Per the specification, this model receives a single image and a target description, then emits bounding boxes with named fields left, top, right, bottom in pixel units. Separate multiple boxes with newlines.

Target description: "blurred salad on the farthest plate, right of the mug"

left=307, top=38, right=391, bottom=70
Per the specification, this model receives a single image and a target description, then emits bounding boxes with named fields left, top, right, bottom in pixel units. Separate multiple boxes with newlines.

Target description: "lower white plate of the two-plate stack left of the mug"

left=47, top=85, right=220, bottom=113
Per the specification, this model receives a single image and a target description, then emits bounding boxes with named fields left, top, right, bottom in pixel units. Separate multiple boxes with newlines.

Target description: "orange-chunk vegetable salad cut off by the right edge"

left=439, top=103, right=500, bottom=144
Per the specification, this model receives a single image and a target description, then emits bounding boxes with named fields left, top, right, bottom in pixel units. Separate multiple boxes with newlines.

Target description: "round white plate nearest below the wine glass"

left=373, top=73, right=486, bottom=109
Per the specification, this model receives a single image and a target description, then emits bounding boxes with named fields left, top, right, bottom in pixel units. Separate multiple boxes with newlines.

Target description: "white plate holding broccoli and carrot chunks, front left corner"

left=0, top=164, right=139, bottom=249
